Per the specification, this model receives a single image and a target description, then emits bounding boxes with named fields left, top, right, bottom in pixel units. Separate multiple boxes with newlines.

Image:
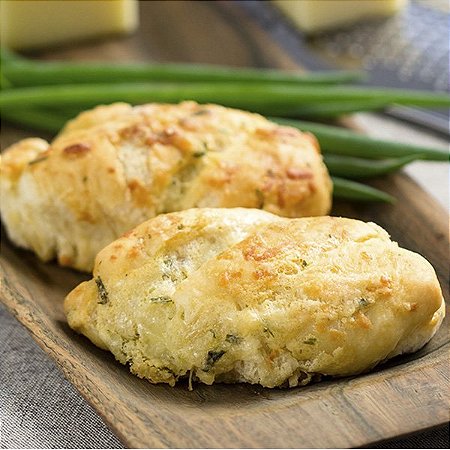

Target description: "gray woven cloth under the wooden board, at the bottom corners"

left=0, top=304, right=449, bottom=448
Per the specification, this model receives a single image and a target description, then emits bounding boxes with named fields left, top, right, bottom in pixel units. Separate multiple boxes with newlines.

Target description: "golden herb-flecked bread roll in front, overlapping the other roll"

left=64, top=208, right=445, bottom=387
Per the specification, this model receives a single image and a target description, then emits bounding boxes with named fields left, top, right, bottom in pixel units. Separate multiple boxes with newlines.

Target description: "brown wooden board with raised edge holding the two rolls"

left=0, top=2, right=450, bottom=448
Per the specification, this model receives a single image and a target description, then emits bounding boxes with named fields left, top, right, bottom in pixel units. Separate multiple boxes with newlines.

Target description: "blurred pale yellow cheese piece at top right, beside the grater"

left=273, top=0, right=408, bottom=33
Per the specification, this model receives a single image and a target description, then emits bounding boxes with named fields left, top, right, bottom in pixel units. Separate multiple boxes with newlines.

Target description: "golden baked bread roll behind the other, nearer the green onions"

left=0, top=102, right=332, bottom=270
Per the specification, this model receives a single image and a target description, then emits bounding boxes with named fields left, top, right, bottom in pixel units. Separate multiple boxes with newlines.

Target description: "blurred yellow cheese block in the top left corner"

left=0, top=0, right=138, bottom=50
